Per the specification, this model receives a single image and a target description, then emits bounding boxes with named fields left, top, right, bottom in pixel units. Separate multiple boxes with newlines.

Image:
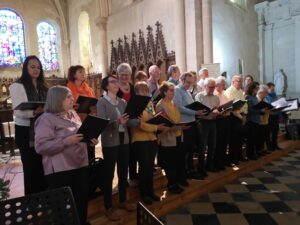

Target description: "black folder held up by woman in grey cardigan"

left=124, top=95, right=151, bottom=119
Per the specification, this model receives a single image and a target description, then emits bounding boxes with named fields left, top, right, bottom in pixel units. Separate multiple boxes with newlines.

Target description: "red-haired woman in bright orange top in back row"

left=67, top=65, right=96, bottom=160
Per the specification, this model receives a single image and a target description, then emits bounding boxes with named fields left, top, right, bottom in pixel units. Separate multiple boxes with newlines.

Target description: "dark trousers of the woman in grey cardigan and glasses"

left=102, top=144, right=129, bottom=209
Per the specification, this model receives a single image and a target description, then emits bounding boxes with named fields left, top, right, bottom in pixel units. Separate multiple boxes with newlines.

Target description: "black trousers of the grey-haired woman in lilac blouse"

left=45, top=167, right=89, bottom=225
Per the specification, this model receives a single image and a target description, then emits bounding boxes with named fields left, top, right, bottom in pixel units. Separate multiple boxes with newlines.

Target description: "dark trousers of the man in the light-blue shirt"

left=182, top=123, right=197, bottom=172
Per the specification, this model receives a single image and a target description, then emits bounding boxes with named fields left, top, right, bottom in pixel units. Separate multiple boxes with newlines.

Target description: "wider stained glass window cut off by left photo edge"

left=0, top=9, right=25, bottom=66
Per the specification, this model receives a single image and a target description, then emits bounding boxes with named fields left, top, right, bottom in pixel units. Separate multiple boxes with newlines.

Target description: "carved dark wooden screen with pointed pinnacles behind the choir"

left=110, top=22, right=175, bottom=80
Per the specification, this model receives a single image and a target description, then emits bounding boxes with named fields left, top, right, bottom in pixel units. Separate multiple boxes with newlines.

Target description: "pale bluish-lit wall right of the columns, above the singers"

left=212, top=0, right=259, bottom=82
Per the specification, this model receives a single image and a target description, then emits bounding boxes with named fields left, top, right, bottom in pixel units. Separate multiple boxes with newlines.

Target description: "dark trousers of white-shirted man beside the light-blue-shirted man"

left=198, top=119, right=217, bottom=173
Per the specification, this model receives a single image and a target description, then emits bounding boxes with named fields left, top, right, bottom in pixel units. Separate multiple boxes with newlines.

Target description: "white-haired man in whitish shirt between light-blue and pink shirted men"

left=195, top=78, right=220, bottom=179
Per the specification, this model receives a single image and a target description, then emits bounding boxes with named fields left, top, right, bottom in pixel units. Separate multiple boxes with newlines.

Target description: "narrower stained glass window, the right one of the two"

left=37, top=22, right=59, bottom=70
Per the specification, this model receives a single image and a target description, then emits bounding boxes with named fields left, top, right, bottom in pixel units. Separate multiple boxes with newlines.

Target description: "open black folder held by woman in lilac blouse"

left=77, top=115, right=110, bottom=143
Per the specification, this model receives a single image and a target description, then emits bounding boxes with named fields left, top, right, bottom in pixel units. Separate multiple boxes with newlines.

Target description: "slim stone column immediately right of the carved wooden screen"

left=174, top=0, right=186, bottom=72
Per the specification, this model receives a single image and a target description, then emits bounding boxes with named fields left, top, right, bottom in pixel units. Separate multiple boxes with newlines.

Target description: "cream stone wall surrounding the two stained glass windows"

left=0, top=0, right=69, bottom=77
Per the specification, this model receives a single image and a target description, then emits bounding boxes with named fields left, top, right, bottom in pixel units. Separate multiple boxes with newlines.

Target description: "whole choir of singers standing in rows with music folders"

left=10, top=56, right=280, bottom=224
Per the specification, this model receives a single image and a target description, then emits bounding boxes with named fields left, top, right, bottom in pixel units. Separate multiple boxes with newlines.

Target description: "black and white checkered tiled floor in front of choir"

left=161, top=150, right=300, bottom=225
